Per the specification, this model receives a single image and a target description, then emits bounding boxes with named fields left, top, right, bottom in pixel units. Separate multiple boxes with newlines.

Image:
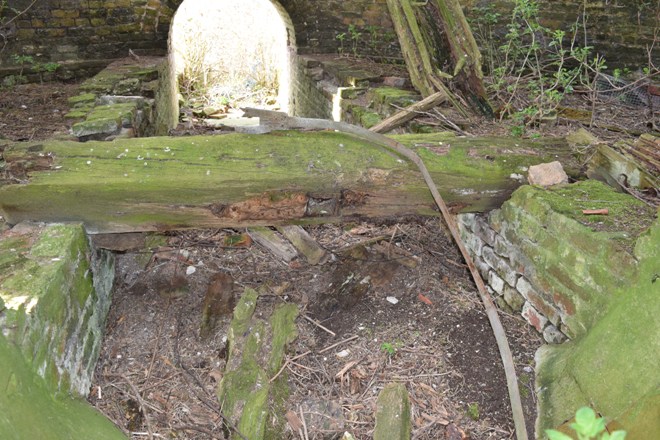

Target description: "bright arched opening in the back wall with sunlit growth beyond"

left=170, top=0, right=292, bottom=115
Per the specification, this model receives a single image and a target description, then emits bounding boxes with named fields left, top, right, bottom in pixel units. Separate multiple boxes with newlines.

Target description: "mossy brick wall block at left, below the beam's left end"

left=0, top=224, right=114, bottom=397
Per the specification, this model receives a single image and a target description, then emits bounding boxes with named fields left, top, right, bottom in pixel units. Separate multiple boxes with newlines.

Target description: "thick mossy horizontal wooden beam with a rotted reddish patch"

left=0, top=131, right=578, bottom=233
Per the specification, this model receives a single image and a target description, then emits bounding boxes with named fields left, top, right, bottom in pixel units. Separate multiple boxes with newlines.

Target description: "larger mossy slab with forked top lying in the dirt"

left=217, top=288, right=298, bottom=440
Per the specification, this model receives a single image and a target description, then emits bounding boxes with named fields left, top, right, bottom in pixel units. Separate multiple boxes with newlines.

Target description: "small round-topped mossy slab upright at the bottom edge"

left=374, top=383, right=412, bottom=440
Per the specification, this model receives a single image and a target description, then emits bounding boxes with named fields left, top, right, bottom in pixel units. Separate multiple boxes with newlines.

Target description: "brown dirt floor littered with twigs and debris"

left=0, top=75, right=648, bottom=440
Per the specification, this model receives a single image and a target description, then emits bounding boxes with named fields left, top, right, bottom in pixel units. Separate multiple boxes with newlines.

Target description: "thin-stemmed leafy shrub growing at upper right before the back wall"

left=472, top=0, right=607, bottom=136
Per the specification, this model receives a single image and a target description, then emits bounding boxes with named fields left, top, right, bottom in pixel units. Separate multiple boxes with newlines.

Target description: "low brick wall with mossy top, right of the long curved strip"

left=459, top=181, right=653, bottom=343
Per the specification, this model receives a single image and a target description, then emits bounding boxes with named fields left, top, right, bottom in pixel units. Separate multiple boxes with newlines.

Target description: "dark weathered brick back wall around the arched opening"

left=0, top=0, right=658, bottom=77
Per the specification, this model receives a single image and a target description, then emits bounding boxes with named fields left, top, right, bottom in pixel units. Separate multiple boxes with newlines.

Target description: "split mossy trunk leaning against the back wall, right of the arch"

left=387, top=0, right=492, bottom=115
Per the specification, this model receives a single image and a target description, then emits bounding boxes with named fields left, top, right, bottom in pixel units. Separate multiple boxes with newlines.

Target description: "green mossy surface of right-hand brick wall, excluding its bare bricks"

left=491, top=181, right=654, bottom=337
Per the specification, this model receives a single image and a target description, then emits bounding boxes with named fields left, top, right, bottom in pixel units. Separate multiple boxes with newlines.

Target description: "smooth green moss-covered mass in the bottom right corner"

left=536, top=220, right=660, bottom=439
